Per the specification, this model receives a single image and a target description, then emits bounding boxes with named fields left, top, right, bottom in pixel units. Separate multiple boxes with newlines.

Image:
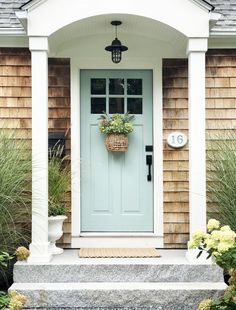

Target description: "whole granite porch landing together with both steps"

left=11, top=250, right=225, bottom=310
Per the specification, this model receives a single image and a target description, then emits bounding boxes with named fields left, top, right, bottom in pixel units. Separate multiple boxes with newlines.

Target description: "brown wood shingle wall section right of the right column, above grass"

left=206, top=50, right=236, bottom=134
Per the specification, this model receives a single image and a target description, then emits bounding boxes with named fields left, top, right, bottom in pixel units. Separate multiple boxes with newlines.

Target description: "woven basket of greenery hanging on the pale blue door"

left=99, top=112, right=134, bottom=152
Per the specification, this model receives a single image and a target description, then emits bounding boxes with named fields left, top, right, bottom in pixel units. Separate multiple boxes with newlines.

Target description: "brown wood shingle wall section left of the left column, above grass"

left=0, top=49, right=31, bottom=134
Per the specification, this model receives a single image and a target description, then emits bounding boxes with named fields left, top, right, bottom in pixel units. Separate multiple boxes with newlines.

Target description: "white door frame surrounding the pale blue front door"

left=71, top=59, right=163, bottom=248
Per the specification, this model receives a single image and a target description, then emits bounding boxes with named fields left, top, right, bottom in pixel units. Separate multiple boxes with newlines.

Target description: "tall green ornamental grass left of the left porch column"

left=0, top=129, right=31, bottom=290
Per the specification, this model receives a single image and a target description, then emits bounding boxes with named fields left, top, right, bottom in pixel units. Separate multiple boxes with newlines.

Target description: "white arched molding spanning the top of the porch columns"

left=19, top=0, right=210, bottom=37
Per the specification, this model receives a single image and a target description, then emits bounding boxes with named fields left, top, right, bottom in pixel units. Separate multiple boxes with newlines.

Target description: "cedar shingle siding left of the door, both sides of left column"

left=0, top=48, right=70, bottom=246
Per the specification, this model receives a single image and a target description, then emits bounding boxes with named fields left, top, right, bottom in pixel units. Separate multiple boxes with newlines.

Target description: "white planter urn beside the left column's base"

left=48, top=215, right=67, bottom=254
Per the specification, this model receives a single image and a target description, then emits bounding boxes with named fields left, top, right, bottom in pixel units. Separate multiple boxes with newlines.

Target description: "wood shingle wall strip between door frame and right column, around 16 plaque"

left=163, top=59, right=189, bottom=248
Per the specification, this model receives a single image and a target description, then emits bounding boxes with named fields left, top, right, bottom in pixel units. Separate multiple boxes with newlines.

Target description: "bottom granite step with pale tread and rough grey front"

left=11, top=282, right=225, bottom=310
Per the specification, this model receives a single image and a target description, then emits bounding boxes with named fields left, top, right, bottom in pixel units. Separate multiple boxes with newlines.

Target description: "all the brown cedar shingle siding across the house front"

left=0, top=48, right=236, bottom=248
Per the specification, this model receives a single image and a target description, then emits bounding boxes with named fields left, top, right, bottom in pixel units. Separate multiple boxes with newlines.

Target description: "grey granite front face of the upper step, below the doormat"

left=14, top=261, right=223, bottom=283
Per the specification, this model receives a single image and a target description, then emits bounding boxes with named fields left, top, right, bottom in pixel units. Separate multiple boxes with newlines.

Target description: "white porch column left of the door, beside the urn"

left=28, top=37, right=51, bottom=262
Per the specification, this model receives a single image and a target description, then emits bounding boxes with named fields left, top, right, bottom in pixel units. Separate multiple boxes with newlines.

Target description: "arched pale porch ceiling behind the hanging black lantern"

left=50, top=14, right=187, bottom=57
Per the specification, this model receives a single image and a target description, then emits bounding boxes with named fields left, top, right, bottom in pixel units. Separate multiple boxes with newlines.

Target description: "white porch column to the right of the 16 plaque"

left=187, top=38, right=207, bottom=236
